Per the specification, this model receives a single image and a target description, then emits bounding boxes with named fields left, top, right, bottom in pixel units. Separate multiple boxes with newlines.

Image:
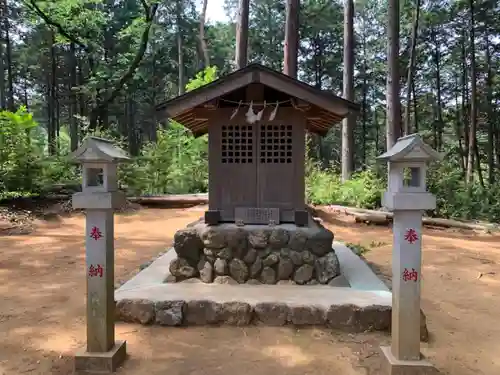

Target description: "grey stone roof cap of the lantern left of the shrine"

left=70, top=137, right=129, bottom=163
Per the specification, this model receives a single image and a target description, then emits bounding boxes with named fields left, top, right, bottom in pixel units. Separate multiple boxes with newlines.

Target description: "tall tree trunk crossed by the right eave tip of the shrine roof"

left=342, top=0, right=355, bottom=181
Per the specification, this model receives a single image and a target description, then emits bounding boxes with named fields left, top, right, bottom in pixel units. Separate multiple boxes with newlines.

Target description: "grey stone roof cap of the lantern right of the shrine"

left=377, top=134, right=443, bottom=162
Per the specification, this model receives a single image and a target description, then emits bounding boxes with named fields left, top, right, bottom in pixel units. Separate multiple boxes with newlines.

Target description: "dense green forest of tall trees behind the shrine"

left=0, top=0, right=500, bottom=222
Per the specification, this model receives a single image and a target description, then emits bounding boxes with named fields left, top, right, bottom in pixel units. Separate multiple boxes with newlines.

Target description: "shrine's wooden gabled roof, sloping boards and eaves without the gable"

left=156, top=63, right=359, bottom=135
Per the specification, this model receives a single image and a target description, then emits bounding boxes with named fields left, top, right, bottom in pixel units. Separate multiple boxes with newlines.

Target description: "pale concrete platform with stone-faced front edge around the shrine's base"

left=115, top=242, right=392, bottom=331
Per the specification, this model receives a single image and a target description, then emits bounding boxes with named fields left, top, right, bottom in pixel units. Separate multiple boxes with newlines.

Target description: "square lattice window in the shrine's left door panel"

left=221, top=125, right=253, bottom=164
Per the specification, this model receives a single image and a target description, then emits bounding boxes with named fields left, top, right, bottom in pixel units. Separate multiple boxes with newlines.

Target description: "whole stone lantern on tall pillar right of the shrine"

left=377, top=134, right=441, bottom=375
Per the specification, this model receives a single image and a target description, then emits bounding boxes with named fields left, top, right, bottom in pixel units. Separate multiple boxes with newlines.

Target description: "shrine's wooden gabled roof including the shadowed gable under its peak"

left=156, top=64, right=359, bottom=136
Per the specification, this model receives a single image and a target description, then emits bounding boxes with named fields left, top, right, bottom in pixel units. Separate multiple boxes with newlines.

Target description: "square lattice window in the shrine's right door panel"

left=259, top=125, right=293, bottom=164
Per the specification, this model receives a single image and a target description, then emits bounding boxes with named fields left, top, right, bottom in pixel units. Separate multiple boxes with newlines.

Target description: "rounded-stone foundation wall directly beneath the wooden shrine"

left=167, top=220, right=340, bottom=285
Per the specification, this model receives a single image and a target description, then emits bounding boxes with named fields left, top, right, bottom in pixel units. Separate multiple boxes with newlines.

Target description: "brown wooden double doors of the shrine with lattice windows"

left=213, top=121, right=304, bottom=224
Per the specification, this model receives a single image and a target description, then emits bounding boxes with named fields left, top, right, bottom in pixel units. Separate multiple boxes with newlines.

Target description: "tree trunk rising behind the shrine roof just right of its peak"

left=283, top=0, right=300, bottom=78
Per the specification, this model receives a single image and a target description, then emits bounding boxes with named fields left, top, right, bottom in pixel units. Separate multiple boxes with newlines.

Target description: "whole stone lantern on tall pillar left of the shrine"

left=72, top=137, right=128, bottom=374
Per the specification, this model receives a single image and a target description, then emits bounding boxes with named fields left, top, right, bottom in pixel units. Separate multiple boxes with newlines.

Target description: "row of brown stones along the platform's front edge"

left=116, top=300, right=391, bottom=332
